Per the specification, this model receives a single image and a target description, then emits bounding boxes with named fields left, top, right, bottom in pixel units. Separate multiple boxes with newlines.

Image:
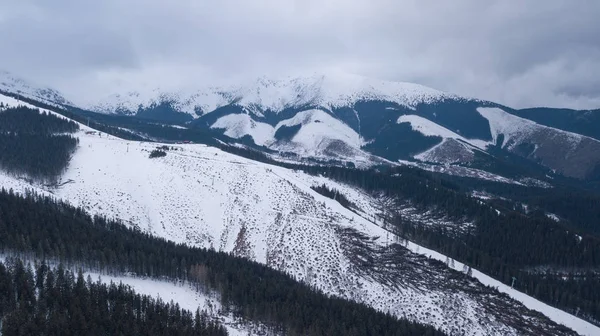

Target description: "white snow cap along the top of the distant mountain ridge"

left=79, top=73, right=456, bottom=117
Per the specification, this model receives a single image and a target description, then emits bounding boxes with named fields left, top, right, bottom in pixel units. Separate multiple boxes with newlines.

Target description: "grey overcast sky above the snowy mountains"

left=0, top=0, right=600, bottom=108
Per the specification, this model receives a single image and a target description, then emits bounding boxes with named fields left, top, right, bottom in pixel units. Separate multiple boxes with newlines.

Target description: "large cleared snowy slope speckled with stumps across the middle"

left=0, top=93, right=600, bottom=335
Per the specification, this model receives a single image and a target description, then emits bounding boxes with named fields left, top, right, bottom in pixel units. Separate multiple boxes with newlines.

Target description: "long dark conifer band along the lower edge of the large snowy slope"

left=0, top=190, right=443, bottom=335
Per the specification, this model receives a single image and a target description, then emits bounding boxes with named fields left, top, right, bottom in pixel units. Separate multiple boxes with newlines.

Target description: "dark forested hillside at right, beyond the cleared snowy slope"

left=304, top=166, right=600, bottom=324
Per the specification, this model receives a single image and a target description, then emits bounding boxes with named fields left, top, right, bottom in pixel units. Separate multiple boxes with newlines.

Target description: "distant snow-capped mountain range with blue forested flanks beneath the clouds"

left=0, top=72, right=600, bottom=181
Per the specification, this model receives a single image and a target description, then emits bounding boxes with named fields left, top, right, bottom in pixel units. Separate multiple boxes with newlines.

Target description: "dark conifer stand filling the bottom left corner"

left=0, top=259, right=227, bottom=336
